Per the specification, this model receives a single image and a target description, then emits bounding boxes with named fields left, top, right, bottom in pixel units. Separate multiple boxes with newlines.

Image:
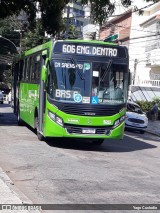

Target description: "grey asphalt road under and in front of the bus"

left=0, top=104, right=160, bottom=211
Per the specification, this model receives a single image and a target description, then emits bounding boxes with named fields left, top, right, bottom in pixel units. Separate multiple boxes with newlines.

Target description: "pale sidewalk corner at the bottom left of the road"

left=0, top=167, right=40, bottom=213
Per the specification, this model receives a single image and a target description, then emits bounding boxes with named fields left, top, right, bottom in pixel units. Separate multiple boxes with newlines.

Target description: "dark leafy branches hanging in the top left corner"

left=0, top=0, right=69, bottom=36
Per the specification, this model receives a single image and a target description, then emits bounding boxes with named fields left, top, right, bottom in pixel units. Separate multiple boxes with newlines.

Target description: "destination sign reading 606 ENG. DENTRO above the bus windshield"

left=53, top=42, right=125, bottom=58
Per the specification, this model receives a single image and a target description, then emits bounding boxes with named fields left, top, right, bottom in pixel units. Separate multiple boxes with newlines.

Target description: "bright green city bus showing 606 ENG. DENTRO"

left=12, top=40, right=129, bottom=144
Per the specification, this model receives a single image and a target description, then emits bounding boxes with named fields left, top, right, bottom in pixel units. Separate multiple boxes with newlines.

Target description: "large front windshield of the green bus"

left=48, top=58, right=128, bottom=104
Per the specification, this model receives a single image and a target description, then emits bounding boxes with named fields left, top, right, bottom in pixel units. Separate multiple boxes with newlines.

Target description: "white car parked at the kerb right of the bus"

left=125, top=101, right=148, bottom=134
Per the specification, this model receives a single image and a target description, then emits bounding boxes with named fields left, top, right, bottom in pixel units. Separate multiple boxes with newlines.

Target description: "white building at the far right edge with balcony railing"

left=137, top=2, right=160, bottom=87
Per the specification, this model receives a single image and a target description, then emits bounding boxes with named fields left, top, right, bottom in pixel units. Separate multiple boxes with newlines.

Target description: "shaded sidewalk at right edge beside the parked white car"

left=146, top=120, right=160, bottom=137
